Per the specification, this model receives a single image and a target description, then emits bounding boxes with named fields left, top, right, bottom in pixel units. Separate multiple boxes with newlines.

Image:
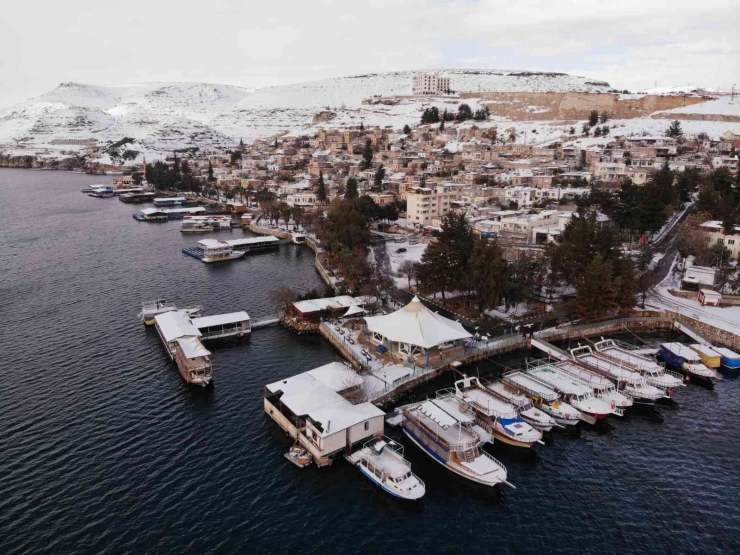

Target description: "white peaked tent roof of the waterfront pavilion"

left=365, top=297, right=472, bottom=349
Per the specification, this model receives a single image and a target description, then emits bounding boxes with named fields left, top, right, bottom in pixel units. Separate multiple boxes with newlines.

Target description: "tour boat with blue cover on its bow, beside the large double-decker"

left=446, top=377, right=542, bottom=448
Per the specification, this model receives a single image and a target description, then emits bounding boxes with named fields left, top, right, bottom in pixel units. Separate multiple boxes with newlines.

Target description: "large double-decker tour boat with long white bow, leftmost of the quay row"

left=401, top=399, right=514, bottom=487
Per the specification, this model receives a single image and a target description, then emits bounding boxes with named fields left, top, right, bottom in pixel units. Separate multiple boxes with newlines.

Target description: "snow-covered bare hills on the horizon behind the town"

left=0, top=70, right=609, bottom=159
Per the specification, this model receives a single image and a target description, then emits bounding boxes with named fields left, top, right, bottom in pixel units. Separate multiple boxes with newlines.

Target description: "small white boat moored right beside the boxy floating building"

left=345, top=435, right=426, bottom=501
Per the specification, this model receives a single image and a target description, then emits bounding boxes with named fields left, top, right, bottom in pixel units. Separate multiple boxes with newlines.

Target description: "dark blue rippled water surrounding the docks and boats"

left=0, top=170, right=740, bottom=554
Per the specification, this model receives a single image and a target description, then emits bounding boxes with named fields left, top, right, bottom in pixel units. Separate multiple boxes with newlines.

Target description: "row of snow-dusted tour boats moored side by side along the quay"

left=363, top=339, right=740, bottom=498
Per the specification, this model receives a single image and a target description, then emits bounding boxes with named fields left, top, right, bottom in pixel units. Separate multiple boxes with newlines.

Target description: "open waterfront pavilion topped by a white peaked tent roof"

left=364, top=297, right=472, bottom=367
